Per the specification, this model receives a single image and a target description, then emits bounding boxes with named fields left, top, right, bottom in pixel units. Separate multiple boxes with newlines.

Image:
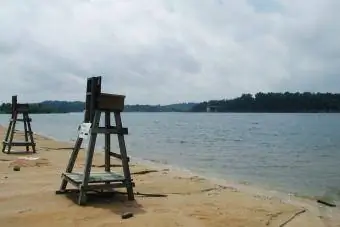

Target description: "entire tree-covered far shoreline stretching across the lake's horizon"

left=0, top=92, right=340, bottom=113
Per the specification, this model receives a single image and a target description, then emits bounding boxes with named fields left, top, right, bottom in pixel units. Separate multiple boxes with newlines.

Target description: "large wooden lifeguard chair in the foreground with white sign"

left=56, top=77, right=135, bottom=205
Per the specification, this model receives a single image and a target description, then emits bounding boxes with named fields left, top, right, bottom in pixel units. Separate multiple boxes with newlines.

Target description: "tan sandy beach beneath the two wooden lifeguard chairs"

left=0, top=127, right=340, bottom=227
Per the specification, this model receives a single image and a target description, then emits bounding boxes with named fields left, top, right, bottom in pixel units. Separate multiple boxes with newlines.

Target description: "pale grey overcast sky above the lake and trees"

left=0, top=0, right=340, bottom=104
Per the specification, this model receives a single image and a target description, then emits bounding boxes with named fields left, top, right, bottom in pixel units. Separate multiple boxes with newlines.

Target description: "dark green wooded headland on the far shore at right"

left=190, top=92, right=340, bottom=113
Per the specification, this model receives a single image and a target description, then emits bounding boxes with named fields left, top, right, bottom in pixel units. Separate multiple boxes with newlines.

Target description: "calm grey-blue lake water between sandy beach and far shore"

left=0, top=113, right=340, bottom=200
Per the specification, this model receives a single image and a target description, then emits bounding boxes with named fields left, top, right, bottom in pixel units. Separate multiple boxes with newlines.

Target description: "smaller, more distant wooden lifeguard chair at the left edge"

left=2, top=95, right=36, bottom=154
